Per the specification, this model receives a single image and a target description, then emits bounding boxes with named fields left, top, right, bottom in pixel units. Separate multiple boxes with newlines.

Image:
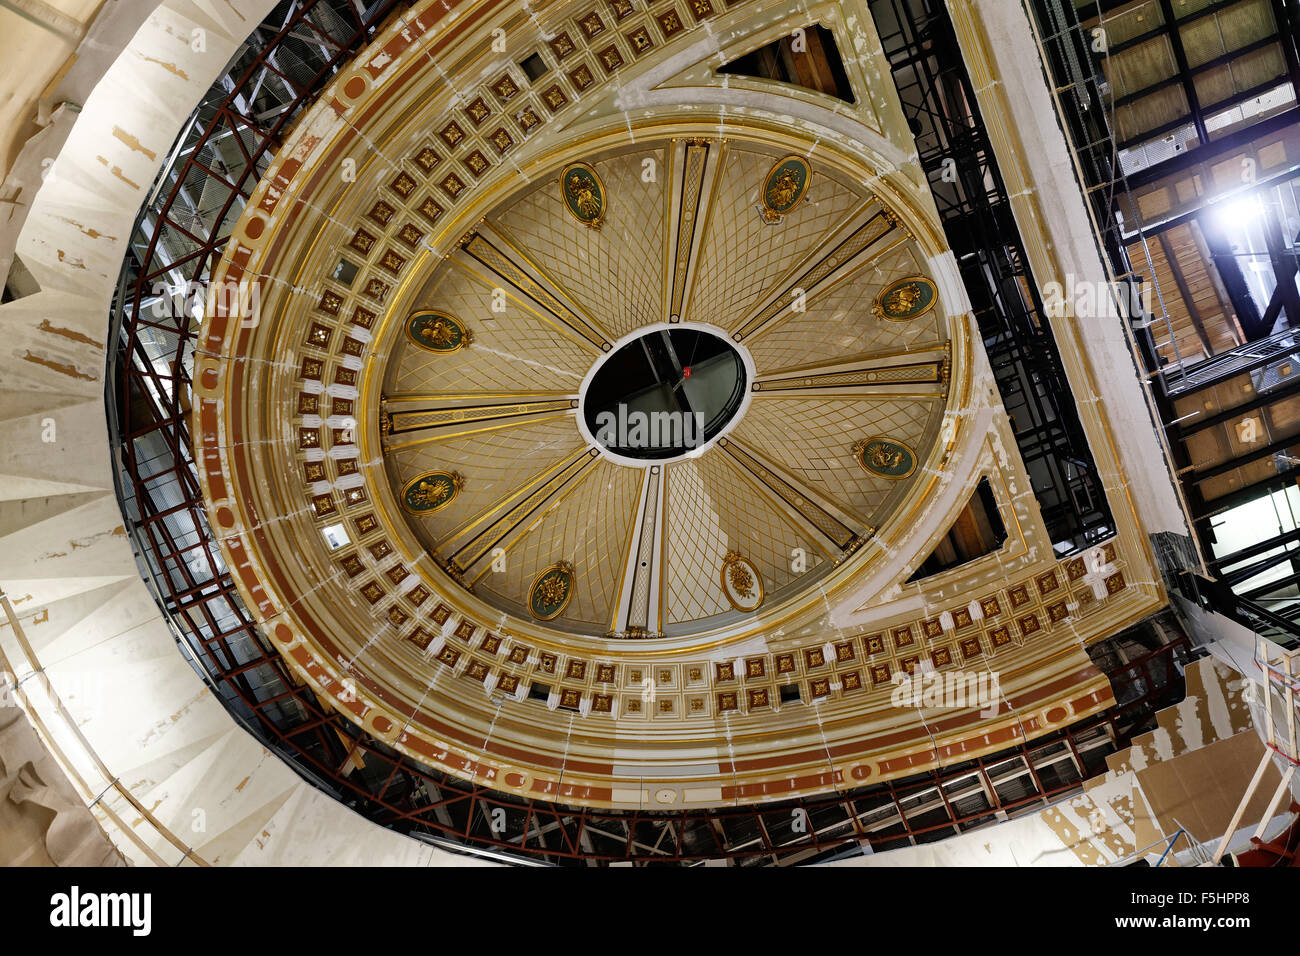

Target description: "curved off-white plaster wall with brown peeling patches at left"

left=0, top=0, right=484, bottom=865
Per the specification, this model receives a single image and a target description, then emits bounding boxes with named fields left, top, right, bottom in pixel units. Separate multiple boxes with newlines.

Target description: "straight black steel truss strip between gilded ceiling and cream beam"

left=870, top=0, right=1114, bottom=554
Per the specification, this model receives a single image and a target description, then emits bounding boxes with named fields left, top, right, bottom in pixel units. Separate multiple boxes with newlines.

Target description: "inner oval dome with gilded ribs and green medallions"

left=381, top=131, right=950, bottom=636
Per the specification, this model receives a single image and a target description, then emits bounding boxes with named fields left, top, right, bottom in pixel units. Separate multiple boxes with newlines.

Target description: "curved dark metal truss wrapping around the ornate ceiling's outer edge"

left=105, top=0, right=1187, bottom=865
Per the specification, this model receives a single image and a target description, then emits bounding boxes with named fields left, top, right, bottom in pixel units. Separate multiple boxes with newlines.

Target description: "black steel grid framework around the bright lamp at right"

left=1030, top=0, right=1300, bottom=645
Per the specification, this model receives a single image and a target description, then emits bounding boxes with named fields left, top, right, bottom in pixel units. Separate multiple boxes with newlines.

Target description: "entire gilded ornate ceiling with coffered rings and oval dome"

left=185, top=0, right=1152, bottom=808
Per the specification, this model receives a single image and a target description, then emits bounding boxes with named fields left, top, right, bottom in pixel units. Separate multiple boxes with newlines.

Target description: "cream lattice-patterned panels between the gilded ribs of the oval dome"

left=385, top=142, right=946, bottom=635
